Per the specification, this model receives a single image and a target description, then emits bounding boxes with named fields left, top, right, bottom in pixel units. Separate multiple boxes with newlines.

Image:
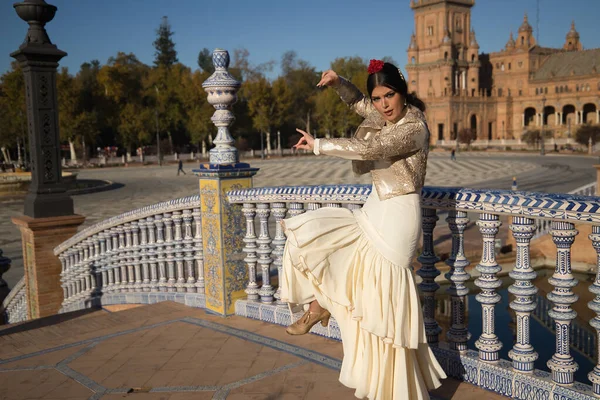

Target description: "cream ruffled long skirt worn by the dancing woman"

left=281, top=187, right=446, bottom=400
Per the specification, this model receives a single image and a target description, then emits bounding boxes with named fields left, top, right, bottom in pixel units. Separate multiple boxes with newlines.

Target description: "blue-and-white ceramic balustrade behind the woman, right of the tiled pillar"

left=228, top=185, right=600, bottom=399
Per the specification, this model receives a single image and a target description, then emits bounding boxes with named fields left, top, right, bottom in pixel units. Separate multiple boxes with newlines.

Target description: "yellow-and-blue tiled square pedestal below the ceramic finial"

left=194, top=164, right=258, bottom=316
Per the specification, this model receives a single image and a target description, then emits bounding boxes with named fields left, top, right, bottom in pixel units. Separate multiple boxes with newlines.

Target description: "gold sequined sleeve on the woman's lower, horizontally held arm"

left=314, top=120, right=427, bottom=160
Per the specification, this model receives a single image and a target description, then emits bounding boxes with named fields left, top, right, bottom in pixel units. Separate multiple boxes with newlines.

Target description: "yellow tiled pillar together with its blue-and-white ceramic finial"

left=194, top=49, right=258, bottom=315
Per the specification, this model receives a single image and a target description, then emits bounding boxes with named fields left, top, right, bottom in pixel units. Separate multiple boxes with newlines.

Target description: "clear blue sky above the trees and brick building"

left=0, top=0, right=600, bottom=78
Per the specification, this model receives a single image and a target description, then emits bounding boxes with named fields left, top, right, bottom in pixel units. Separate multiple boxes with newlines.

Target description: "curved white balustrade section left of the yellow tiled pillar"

left=54, top=195, right=204, bottom=312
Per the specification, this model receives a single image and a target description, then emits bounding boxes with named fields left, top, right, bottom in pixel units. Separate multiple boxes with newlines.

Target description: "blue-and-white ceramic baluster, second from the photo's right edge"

left=547, top=221, right=579, bottom=385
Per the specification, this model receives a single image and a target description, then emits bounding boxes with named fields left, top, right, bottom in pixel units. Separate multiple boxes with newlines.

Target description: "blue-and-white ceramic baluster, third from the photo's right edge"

left=508, top=217, right=546, bottom=372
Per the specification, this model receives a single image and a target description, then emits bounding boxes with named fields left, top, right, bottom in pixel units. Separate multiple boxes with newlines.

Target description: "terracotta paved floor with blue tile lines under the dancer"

left=0, top=302, right=503, bottom=400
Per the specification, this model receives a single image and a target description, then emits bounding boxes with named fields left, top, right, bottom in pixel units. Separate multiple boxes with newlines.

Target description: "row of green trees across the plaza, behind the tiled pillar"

left=0, top=46, right=408, bottom=157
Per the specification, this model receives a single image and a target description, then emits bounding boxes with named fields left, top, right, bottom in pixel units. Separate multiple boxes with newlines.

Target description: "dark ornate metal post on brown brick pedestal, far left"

left=11, top=0, right=84, bottom=318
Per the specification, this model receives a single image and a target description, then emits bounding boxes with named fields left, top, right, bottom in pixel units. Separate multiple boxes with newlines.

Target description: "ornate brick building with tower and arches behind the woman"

left=406, top=0, right=600, bottom=143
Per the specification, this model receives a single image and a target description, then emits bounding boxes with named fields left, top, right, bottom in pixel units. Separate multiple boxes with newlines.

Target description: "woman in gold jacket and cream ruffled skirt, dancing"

left=281, top=60, right=446, bottom=400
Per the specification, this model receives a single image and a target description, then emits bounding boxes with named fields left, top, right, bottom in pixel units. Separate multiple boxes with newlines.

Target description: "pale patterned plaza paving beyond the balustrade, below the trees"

left=0, top=153, right=536, bottom=286
